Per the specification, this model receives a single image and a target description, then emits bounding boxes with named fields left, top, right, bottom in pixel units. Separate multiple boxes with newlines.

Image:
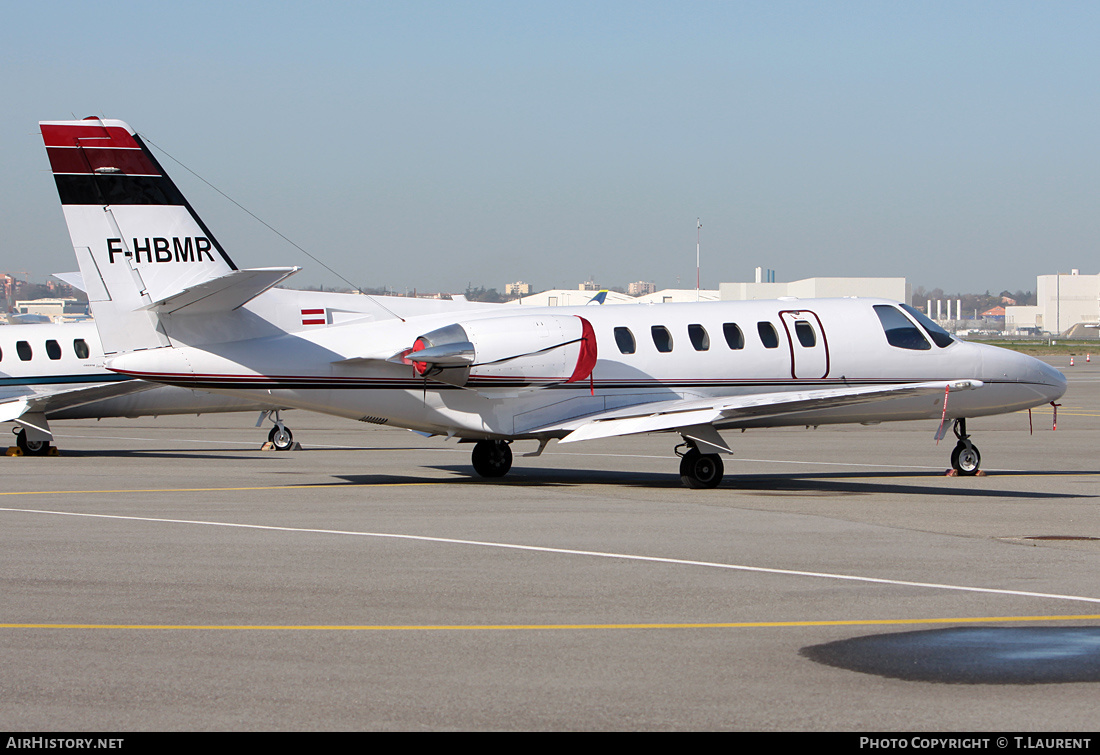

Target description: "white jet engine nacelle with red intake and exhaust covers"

left=405, top=315, right=596, bottom=387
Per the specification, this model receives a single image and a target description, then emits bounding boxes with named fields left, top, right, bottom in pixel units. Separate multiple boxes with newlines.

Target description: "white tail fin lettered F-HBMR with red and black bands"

left=39, top=118, right=237, bottom=353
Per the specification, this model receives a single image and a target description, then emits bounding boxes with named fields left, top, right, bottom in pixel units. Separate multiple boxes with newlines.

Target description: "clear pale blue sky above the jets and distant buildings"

left=0, top=1, right=1100, bottom=292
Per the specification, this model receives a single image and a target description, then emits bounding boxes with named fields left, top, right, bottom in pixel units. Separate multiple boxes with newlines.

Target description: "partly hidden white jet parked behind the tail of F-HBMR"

left=0, top=322, right=294, bottom=456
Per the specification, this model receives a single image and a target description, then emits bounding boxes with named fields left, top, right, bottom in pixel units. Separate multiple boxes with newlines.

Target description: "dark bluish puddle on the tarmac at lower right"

left=800, top=626, right=1100, bottom=685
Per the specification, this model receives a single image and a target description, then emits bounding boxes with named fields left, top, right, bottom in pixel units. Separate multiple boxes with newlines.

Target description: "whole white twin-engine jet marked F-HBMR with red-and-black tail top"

left=41, top=118, right=1066, bottom=488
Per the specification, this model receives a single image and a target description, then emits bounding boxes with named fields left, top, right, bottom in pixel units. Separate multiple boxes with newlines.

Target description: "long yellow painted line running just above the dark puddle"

left=0, top=614, right=1100, bottom=632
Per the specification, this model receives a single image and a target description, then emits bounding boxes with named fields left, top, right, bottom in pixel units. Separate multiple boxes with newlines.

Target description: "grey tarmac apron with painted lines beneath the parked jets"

left=0, top=359, right=1100, bottom=733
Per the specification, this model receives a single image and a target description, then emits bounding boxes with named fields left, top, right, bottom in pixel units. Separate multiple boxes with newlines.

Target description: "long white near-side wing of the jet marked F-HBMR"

left=532, top=380, right=982, bottom=448
